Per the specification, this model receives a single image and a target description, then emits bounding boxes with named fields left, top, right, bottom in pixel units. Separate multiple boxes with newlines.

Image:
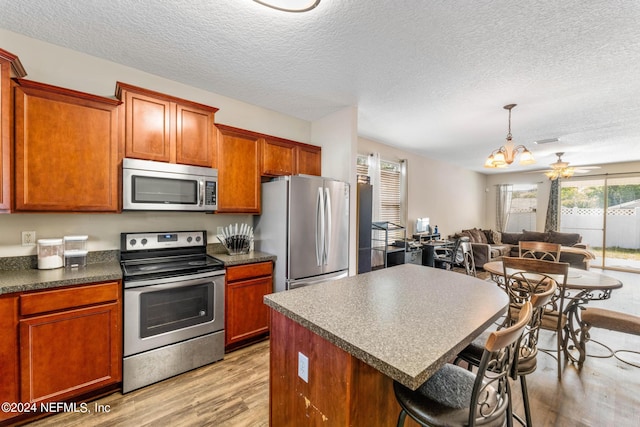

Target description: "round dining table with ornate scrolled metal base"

left=483, top=261, right=622, bottom=366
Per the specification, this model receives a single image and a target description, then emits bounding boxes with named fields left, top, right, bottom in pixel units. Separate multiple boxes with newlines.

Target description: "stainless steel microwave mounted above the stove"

left=122, top=158, right=218, bottom=212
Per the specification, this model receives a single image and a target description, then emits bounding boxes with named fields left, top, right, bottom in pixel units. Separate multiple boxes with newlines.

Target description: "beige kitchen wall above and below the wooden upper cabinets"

left=0, top=29, right=316, bottom=257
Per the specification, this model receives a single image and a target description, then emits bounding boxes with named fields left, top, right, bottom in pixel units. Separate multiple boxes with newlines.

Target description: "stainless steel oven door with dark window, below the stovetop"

left=124, top=273, right=224, bottom=356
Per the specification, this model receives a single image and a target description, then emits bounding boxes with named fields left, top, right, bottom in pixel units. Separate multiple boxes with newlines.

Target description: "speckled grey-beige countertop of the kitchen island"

left=264, top=264, right=509, bottom=389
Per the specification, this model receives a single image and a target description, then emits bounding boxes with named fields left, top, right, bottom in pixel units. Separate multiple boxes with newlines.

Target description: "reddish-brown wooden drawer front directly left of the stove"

left=20, top=282, right=120, bottom=316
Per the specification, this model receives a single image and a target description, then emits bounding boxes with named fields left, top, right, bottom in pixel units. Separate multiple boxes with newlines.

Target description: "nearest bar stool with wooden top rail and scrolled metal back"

left=393, top=302, right=533, bottom=427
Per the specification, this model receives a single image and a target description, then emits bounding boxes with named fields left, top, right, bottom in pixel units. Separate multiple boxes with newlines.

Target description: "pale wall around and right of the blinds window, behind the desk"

left=353, top=138, right=487, bottom=237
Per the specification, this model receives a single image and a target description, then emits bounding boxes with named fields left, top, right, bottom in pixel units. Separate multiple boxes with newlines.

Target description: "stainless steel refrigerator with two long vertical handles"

left=254, top=175, right=349, bottom=292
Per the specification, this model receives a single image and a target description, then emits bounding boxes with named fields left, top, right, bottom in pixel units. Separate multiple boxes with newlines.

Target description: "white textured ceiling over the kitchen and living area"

left=0, top=0, right=640, bottom=173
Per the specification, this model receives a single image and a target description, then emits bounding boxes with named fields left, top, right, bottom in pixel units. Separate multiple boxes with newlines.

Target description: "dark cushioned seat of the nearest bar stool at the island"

left=393, top=363, right=506, bottom=426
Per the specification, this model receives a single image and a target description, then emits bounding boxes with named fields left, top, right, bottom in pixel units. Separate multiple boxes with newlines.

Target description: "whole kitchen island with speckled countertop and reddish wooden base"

left=265, top=264, right=508, bottom=426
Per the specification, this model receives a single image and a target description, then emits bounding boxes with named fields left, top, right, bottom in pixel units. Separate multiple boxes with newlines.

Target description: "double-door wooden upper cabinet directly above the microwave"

left=116, top=82, right=218, bottom=167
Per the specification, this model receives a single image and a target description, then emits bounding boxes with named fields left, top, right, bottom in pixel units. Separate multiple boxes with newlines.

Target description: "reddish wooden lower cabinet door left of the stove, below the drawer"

left=19, top=302, right=122, bottom=402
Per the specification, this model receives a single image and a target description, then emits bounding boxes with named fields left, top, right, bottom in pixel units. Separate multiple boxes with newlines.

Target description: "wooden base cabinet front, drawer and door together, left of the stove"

left=17, top=282, right=122, bottom=402
